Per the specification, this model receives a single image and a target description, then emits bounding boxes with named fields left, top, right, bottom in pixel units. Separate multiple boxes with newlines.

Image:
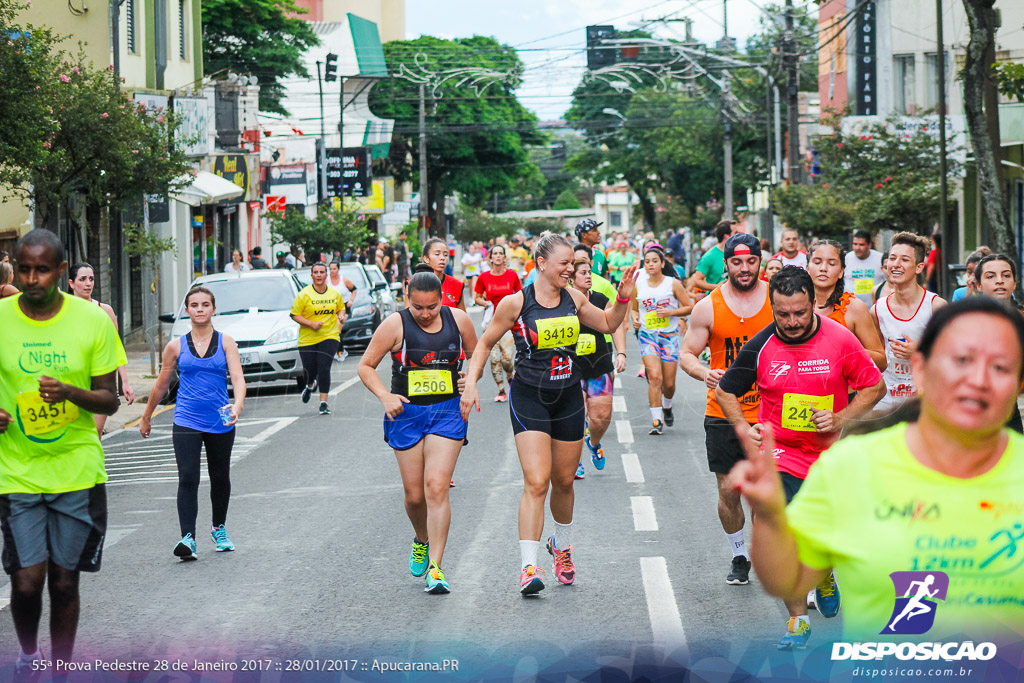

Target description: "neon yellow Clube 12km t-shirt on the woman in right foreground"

left=786, top=424, right=1024, bottom=642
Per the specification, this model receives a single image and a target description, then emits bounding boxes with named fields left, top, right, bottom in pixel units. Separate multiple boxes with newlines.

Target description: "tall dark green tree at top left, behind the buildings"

left=203, top=0, right=319, bottom=116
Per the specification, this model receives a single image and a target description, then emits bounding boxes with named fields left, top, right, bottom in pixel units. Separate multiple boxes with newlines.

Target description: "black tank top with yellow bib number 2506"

left=391, top=306, right=463, bottom=405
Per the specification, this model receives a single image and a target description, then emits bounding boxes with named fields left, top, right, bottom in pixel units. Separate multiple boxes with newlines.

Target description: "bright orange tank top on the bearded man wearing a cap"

left=705, top=287, right=775, bottom=424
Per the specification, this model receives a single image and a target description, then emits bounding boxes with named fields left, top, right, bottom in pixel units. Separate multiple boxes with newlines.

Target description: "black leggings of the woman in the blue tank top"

left=171, top=425, right=234, bottom=539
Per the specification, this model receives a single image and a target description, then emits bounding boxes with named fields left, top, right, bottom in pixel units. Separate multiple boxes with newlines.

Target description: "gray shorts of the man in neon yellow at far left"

left=0, top=484, right=106, bottom=574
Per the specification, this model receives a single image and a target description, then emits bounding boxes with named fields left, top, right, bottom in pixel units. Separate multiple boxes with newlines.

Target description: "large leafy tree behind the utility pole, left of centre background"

left=370, top=36, right=544, bottom=235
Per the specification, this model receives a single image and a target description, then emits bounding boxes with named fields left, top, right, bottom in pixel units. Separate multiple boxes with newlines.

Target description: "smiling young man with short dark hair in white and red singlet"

left=871, top=232, right=946, bottom=412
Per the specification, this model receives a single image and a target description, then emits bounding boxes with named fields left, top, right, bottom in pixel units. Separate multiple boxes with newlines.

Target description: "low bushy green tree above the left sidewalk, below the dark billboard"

left=269, top=205, right=370, bottom=256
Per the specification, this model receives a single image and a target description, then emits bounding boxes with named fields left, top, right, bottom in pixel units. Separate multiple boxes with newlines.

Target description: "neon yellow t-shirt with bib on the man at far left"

left=0, top=294, right=128, bottom=494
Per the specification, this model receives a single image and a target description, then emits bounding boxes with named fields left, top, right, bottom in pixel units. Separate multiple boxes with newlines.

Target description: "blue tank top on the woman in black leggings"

left=174, top=332, right=234, bottom=434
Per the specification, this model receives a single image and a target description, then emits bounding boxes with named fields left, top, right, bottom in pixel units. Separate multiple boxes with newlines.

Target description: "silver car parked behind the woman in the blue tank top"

left=160, top=269, right=304, bottom=386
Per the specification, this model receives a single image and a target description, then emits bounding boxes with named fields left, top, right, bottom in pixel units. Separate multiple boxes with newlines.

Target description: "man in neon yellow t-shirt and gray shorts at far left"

left=0, top=229, right=127, bottom=680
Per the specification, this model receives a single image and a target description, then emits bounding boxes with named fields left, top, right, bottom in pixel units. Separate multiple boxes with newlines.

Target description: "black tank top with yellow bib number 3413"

left=512, top=285, right=580, bottom=389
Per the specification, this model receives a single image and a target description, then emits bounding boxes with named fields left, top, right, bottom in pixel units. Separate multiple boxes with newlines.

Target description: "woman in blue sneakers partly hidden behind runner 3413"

left=572, top=259, right=626, bottom=479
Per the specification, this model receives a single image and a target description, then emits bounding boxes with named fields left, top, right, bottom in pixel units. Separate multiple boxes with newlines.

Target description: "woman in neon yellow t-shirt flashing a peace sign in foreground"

left=730, top=297, right=1024, bottom=642
